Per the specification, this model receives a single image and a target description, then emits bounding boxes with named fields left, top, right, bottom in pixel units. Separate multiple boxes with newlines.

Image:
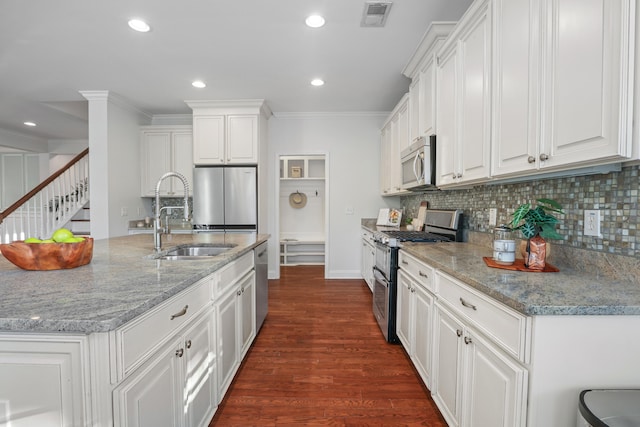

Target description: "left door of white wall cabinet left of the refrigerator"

left=141, top=132, right=171, bottom=196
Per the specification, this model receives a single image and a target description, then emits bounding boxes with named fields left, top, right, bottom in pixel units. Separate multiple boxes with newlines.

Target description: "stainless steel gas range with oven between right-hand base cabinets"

left=373, top=209, right=462, bottom=344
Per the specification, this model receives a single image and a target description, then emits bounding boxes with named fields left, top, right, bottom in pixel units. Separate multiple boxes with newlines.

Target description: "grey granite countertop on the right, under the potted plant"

left=362, top=220, right=640, bottom=316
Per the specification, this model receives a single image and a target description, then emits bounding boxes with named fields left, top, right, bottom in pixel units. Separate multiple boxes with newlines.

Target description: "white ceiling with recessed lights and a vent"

left=0, top=0, right=471, bottom=144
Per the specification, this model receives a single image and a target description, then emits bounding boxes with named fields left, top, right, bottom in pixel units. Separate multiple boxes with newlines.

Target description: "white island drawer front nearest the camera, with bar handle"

left=116, top=278, right=211, bottom=379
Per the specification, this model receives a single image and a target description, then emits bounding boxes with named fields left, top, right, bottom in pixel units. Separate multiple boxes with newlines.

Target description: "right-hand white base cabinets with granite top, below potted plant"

left=362, top=220, right=640, bottom=427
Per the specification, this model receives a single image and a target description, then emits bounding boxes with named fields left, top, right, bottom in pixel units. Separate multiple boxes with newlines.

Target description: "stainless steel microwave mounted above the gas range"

left=400, top=135, right=436, bottom=191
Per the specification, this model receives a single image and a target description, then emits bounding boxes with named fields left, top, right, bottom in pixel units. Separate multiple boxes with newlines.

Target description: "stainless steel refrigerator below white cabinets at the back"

left=193, top=166, right=258, bottom=232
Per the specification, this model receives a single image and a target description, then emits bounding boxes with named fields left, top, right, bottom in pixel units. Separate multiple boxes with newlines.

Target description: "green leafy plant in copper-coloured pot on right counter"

left=510, top=199, right=564, bottom=270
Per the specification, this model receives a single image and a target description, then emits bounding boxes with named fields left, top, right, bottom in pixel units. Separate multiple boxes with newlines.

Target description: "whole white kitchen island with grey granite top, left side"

left=0, top=233, right=269, bottom=426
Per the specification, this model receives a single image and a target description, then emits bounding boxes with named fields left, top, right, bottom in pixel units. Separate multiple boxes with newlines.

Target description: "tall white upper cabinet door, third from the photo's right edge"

left=456, top=2, right=491, bottom=182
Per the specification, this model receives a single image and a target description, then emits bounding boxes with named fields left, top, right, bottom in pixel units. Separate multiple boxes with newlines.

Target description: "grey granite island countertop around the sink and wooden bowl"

left=0, top=233, right=269, bottom=334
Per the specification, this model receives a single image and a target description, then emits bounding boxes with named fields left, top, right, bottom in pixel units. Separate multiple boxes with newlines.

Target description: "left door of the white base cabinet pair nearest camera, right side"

left=431, top=305, right=464, bottom=426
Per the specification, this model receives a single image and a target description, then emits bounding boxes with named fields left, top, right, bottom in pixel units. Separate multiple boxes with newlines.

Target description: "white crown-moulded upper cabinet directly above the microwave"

left=402, top=22, right=455, bottom=143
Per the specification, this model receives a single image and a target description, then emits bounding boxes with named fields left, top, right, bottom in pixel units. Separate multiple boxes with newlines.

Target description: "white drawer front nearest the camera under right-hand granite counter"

left=436, top=272, right=527, bottom=362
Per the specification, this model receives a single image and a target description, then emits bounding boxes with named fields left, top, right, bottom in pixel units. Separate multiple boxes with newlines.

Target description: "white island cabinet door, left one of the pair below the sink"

left=216, top=286, right=240, bottom=399
